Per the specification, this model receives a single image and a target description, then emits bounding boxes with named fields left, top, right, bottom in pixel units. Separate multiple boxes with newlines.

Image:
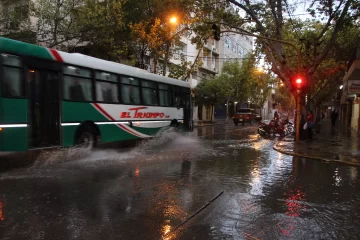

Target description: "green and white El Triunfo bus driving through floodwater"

left=0, top=38, right=193, bottom=152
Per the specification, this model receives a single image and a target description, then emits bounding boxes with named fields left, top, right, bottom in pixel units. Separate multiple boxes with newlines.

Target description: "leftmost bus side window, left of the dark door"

left=1, top=54, right=24, bottom=97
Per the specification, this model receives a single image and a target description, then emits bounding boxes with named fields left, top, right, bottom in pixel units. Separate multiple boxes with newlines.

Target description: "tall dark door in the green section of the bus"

left=27, top=58, right=61, bottom=148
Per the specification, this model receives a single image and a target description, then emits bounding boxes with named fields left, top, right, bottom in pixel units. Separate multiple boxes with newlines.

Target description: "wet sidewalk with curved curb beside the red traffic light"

left=273, top=119, right=360, bottom=167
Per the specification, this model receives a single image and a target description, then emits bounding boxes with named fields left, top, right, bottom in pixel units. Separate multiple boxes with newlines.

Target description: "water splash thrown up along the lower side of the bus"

left=30, top=128, right=215, bottom=169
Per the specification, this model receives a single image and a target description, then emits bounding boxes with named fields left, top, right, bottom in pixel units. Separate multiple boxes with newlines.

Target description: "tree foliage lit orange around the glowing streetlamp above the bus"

left=124, top=0, right=197, bottom=75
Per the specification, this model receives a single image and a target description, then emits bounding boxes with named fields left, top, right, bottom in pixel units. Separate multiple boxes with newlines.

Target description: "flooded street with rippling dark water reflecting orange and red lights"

left=0, top=124, right=360, bottom=240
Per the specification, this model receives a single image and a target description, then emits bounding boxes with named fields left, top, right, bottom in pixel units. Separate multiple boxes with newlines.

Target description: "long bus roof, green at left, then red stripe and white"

left=0, top=37, right=190, bottom=88
